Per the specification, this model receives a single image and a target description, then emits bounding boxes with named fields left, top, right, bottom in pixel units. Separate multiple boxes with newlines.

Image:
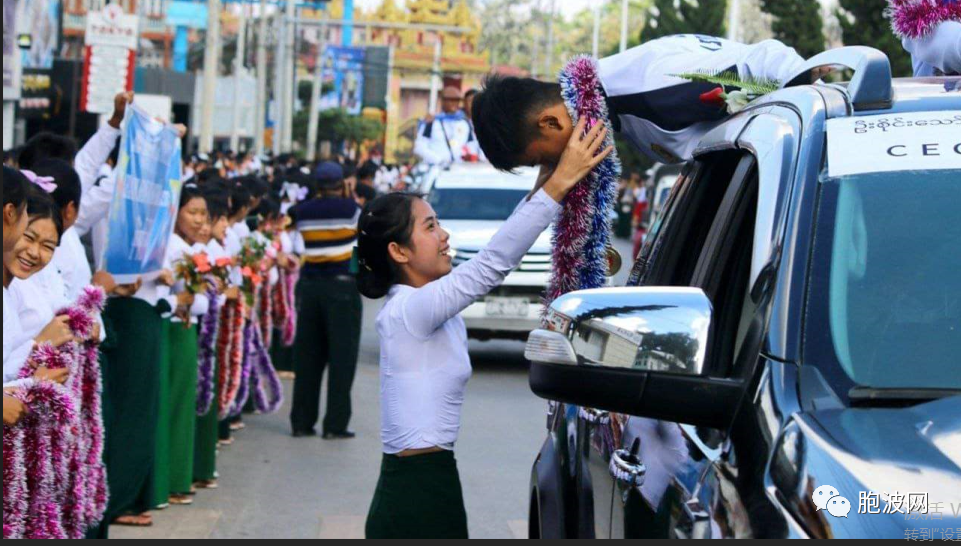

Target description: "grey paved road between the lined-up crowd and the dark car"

left=110, top=236, right=630, bottom=538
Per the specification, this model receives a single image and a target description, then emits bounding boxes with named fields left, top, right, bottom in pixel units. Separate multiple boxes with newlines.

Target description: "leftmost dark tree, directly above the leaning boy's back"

left=641, top=0, right=727, bottom=42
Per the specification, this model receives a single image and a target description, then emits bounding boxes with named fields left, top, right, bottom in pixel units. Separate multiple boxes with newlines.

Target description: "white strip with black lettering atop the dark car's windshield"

left=827, top=110, right=961, bottom=178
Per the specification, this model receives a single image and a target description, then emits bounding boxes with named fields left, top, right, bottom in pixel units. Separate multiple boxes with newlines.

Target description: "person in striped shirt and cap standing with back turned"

left=290, top=162, right=362, bottom=439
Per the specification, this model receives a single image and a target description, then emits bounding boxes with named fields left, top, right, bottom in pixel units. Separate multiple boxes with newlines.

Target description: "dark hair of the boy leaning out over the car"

left=472, top=75, right=561, bottom=171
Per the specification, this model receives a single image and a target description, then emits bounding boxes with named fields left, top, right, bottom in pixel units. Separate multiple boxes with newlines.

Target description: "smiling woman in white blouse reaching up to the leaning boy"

left=358, top=120, right=610, bottom=538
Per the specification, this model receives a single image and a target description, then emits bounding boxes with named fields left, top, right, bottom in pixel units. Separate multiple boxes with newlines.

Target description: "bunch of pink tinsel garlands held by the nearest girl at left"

left=3, top=287, right=107, bottom=539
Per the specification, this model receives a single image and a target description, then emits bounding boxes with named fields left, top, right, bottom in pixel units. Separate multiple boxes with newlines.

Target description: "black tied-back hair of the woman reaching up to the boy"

left=357, top=193, right=423, bottom=300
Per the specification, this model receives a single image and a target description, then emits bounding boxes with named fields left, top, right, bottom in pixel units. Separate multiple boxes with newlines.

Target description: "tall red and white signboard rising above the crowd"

left=80, top=4, right=140, bottom=114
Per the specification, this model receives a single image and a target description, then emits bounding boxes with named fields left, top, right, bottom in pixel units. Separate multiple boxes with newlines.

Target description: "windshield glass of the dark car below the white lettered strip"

left=805, top=170, right=961, bottom=393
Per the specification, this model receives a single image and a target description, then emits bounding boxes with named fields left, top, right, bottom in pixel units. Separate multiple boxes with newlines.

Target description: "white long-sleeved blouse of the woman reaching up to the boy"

left=377, top=191, right=561, bottom=454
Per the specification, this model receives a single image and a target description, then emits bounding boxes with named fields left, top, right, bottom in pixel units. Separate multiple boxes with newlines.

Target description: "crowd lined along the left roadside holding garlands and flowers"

left=3, top=94, right=404, bottom=538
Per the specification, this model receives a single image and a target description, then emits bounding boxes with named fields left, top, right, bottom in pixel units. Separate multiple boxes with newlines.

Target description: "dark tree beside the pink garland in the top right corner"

left=836, top=0, right=914, bottom=76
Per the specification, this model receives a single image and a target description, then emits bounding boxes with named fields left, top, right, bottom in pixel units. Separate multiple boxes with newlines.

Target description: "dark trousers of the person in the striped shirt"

left=290, top=276, right=363, bottom=433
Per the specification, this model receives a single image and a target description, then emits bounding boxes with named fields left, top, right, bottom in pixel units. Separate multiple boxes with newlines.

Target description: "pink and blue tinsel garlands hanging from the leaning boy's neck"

left=545, top=56, right=621, bottom=304
